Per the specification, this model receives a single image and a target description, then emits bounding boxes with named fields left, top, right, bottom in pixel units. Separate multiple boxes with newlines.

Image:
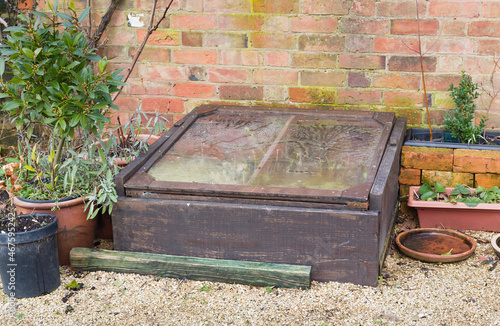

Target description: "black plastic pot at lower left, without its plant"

left=0, top=214, right=61, bottom=298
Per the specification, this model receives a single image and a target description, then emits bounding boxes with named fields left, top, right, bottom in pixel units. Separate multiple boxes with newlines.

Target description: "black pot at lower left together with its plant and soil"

left=0, top=191, right=61, bottom=305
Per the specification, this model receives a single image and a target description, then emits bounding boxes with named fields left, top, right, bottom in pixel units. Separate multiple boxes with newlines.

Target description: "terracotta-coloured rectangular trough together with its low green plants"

left=408, top=182, right=500, bottom=232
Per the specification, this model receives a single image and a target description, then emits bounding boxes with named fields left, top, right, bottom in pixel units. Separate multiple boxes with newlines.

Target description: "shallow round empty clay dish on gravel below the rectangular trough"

left=396, top=228, right=476, bottom=263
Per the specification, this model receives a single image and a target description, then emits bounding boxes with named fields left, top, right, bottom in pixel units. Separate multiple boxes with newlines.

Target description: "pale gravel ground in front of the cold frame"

left=0, top=211, right=500, bottom=325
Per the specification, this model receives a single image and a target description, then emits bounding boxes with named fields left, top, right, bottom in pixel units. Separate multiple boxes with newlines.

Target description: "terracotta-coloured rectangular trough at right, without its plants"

left=408, top=187, right=500, bottom=232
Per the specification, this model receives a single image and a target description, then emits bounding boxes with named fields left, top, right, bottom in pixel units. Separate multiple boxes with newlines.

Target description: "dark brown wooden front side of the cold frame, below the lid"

left=112, top=197, right=379, bottom=285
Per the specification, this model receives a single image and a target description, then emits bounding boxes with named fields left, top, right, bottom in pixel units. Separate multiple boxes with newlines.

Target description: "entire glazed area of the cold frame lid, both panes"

left=148, top=113, right=383, bottom=190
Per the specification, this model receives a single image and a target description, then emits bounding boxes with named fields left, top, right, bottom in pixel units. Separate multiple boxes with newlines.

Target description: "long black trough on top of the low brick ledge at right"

left=403, top=128, right=500, bottom=151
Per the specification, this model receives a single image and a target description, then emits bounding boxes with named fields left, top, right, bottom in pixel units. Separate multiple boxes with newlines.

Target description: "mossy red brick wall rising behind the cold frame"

left=44, top=0, right=500, bottom=128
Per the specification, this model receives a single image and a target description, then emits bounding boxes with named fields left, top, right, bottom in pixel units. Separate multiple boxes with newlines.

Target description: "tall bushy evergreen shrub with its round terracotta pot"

left=0, top=2, right=123, bottom=264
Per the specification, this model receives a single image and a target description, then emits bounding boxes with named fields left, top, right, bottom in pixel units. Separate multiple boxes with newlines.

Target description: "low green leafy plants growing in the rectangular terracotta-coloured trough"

left=419, top=182, right=500, bottom=207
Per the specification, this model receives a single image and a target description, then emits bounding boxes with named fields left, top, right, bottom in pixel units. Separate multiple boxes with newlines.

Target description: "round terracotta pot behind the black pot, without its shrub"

left=14, top=197, right=96, bottom=265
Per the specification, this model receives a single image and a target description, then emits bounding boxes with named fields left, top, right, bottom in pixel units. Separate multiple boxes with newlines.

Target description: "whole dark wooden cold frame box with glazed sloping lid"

left=112, top=105, right=406, bottom=285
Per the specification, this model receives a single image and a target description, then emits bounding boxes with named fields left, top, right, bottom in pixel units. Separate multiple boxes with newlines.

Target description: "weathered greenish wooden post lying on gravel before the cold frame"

left=70, top=248, right=311, bottom=289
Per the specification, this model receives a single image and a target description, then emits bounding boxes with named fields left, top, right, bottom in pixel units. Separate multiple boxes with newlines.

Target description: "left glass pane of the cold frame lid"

left=148, top=114, right=289, bottom=185
